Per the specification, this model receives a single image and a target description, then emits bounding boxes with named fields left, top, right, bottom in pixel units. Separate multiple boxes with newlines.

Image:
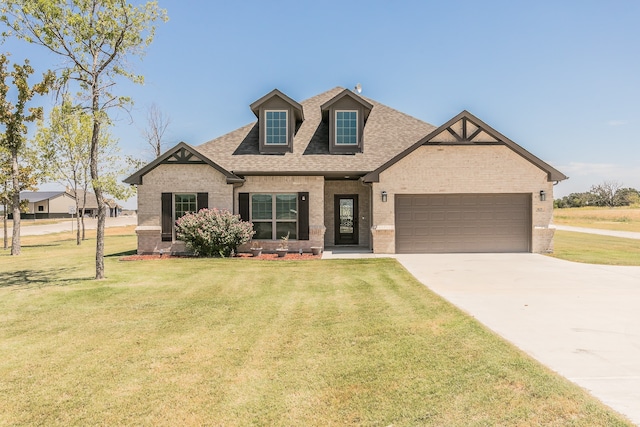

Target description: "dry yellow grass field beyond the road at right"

left=553, top=207, right=640, bottom=232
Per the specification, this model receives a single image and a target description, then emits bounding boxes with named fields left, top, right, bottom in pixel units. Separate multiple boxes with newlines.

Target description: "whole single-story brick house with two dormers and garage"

left=125, top=88, right=567, bottom=253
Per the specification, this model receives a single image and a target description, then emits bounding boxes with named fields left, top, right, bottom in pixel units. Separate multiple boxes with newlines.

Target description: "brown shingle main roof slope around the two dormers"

left=197, top=87, right=435, bottom=175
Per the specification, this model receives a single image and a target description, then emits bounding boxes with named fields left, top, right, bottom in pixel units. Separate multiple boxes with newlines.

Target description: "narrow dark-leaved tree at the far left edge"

left=0, top=55, right=54, bottom=255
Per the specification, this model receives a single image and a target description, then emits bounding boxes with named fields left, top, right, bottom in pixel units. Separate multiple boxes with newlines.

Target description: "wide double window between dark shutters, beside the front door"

left=251, top=194, right=298, bottom=240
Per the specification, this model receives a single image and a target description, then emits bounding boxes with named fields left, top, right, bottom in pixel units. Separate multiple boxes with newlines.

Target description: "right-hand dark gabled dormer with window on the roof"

left=320, top=89, right=373, bottom=154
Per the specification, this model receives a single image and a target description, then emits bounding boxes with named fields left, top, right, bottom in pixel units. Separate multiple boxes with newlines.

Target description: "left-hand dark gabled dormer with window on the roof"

left=250, top=89, right=304, bottom=154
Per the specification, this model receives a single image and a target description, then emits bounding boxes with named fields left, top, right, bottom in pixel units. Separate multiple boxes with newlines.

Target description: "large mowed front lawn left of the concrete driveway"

left=0, top=229, right=631, bottom=426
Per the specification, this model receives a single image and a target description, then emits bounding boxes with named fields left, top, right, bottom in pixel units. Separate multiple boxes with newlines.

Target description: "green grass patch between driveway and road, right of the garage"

left=551, top=230, right=640, bottom=266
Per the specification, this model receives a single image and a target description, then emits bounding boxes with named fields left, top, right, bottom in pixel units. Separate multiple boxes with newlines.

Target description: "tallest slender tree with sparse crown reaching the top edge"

left=1, top=0, right=167, bottom=279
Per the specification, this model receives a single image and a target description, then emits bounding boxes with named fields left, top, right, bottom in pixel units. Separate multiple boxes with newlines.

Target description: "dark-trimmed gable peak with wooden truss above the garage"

left=362, top=110, right=568, bottom=182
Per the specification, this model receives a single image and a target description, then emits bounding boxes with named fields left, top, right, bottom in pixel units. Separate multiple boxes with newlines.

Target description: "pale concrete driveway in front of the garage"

left=395, top=254, right=640, bottom=425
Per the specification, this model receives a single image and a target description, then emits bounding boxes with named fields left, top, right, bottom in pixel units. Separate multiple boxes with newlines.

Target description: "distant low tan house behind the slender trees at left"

left=16, top=189, right=122, bottom=219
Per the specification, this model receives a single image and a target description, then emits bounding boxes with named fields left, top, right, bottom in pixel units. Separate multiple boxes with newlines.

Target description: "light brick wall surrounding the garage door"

left=372, top=145, right=553, bottom=253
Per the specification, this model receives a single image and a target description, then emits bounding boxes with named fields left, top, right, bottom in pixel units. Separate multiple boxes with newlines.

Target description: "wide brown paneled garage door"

left=395, top=194, right=531, bottom=253
